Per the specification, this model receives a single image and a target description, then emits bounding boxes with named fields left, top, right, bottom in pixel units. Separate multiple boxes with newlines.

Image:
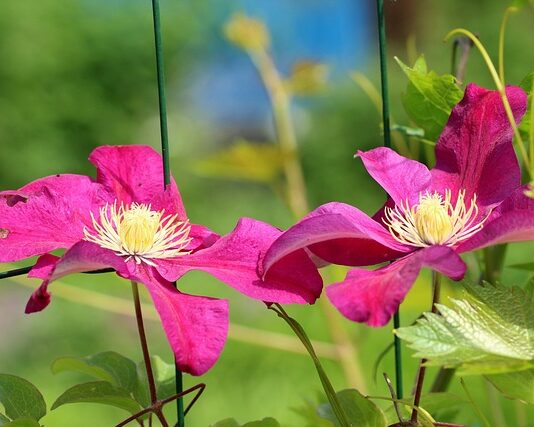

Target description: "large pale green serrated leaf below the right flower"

left=396, top=282, right=534, bottom=375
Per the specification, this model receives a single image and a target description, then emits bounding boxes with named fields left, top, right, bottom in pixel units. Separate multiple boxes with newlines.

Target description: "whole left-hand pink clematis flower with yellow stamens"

left=0, top=146, right=322, bottom=375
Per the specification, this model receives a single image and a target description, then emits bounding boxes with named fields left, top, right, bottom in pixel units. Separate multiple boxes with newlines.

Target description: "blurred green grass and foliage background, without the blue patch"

left=0, top=0, right=534, bottom=427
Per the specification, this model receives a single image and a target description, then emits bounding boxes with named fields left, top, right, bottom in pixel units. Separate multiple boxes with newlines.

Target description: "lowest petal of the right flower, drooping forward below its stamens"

left=326, top=246, right=466, bottom=326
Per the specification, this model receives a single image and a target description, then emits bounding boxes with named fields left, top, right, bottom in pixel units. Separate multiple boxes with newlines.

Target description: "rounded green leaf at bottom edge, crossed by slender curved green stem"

left=317, top=389, right=387, bottom=427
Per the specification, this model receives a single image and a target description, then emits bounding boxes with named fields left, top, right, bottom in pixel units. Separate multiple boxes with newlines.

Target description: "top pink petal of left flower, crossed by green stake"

left=89, top=145, right=186, bottom=218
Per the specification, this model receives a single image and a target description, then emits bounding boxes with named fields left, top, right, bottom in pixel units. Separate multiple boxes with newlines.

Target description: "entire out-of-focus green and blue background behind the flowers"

left=0, top=0, right=534, bottom=427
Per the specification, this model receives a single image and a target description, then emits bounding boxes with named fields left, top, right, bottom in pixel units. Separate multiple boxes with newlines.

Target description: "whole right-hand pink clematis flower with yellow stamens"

left=263, top=84, right=534, bottom=326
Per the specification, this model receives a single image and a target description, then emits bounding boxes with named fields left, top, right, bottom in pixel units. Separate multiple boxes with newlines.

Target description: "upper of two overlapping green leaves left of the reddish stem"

left=51, top=351, right=137, bottom=392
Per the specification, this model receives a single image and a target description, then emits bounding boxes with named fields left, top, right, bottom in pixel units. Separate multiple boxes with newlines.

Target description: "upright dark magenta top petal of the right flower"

left=432, top=84, right=527, bottom=207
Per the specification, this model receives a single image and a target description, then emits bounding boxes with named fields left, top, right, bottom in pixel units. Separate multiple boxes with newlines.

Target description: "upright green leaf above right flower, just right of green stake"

left=395, top=56, right=463, bottom=141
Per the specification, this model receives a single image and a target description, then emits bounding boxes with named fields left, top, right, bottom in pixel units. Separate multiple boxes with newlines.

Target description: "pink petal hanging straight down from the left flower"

left=134, top=265, right=229, bottom=375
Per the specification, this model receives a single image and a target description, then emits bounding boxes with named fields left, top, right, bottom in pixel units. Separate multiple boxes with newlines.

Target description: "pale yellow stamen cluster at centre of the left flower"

left=83, top=203, right=192, bottom=266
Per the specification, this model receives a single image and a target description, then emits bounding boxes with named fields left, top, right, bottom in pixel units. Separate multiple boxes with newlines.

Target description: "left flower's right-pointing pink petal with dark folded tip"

left=156, top=218, right=322, bottom=304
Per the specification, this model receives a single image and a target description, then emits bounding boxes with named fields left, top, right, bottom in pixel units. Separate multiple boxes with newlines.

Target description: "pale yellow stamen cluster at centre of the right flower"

left=384, top=190, right=488, bottom=247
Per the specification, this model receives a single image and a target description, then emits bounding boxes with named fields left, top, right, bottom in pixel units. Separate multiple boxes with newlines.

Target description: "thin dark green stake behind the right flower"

left=376, top=0, right=404, bottom=399
